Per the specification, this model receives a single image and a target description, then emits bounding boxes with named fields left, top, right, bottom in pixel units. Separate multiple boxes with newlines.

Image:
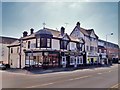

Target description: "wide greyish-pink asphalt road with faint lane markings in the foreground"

left=2, top=64, right=119, bottom=88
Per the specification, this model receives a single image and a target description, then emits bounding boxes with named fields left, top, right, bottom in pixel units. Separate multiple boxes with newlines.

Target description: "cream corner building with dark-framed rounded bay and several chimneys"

left=8, top=27, right=84, bottom=68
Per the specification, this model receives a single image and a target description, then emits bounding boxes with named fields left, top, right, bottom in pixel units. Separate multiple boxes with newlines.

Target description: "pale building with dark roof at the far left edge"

left=0, top=36, right=17, bottom=64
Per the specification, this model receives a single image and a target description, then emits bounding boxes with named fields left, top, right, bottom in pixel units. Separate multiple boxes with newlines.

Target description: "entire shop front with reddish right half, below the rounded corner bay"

left=25, top=51, right=60, bottom=68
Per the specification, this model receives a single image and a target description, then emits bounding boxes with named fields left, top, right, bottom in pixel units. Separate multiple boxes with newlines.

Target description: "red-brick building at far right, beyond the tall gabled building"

left=98, top=39, right=119, bottom=64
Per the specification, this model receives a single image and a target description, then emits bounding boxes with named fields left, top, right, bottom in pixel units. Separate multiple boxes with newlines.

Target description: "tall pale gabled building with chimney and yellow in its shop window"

left=70, top=22, right=99, bottom=64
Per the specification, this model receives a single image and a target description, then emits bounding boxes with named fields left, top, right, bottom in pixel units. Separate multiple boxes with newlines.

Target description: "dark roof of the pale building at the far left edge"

left=0, top=36, right=18, bottom=44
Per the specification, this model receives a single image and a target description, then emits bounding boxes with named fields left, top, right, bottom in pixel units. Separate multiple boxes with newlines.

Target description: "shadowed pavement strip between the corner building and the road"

left=2, top=65, right=112, bottom=74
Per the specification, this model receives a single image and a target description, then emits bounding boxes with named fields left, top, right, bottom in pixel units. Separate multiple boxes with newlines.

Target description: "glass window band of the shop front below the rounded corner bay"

left=25, top=52, right=59, bottom=67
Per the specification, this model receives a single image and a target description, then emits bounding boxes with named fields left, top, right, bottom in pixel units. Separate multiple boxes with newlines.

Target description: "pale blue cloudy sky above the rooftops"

left=0, top=0, right=118, bottom=43
